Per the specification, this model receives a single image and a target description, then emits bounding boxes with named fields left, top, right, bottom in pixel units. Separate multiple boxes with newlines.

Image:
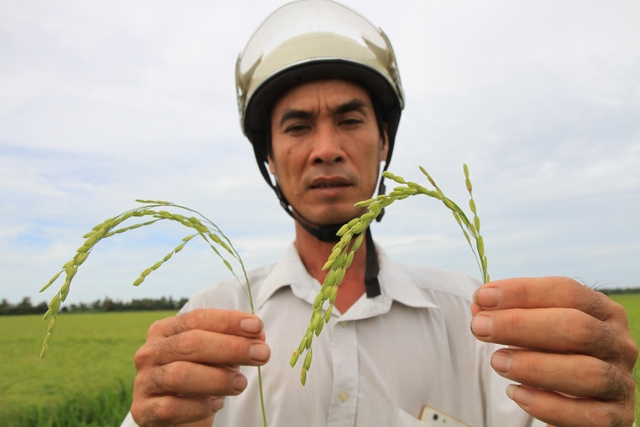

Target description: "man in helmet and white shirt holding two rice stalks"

left=123, top=0, right=637, bottom=427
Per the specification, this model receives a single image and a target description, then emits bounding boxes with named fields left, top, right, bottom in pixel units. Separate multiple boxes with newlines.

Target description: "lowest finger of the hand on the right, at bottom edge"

left=507, top=385, right=634, bottom=427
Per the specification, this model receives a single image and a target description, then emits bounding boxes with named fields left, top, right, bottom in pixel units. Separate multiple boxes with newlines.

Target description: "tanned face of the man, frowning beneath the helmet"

left=269, top=80, right=388, bottom=226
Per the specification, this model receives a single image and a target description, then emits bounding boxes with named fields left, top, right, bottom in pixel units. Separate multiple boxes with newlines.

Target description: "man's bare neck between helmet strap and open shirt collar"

left=295, top=221, right=367, bottom=313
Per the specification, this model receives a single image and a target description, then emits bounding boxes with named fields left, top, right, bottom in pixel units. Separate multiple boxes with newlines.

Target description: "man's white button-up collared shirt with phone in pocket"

left=122, top=245, right=543, bottom=427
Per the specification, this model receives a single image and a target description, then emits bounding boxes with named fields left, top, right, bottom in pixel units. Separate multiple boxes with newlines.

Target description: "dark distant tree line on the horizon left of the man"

left=0, top=297, right=188, bottom=316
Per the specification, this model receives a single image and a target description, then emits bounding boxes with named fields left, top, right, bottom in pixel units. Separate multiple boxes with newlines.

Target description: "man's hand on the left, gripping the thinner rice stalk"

left=131, top=309, right=271, bottom=427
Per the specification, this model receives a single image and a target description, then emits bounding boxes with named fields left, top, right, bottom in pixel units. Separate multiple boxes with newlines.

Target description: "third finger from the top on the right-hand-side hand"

left=491, top=349, right=635, bottom=401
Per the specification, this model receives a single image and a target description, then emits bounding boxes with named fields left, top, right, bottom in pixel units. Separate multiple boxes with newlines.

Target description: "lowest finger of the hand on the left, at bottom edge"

left=131, top=396, right=224, bottom=426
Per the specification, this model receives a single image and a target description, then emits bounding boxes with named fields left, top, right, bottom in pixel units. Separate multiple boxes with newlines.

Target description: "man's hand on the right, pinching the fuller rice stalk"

left=471, top=277, right=638, bottom=427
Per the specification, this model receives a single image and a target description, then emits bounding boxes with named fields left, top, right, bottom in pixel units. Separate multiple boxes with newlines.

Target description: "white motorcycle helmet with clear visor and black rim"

left=236, top=0, right=404, bottom=205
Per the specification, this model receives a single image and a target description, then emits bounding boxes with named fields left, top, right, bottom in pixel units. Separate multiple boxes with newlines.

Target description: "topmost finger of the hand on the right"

left=473, top=277, right=627, bottom=325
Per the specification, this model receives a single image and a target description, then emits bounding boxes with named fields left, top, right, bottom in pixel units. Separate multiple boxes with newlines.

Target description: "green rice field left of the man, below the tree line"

left=0, top=312, right=175, bottom=427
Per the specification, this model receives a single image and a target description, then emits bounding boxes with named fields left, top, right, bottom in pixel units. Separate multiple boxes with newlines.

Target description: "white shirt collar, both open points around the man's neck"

left=256, top=243, right=439, bottom=321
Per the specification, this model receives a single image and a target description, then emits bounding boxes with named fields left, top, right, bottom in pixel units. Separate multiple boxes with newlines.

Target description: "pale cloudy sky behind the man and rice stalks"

left=0, top=0, right=640, bottom=303
